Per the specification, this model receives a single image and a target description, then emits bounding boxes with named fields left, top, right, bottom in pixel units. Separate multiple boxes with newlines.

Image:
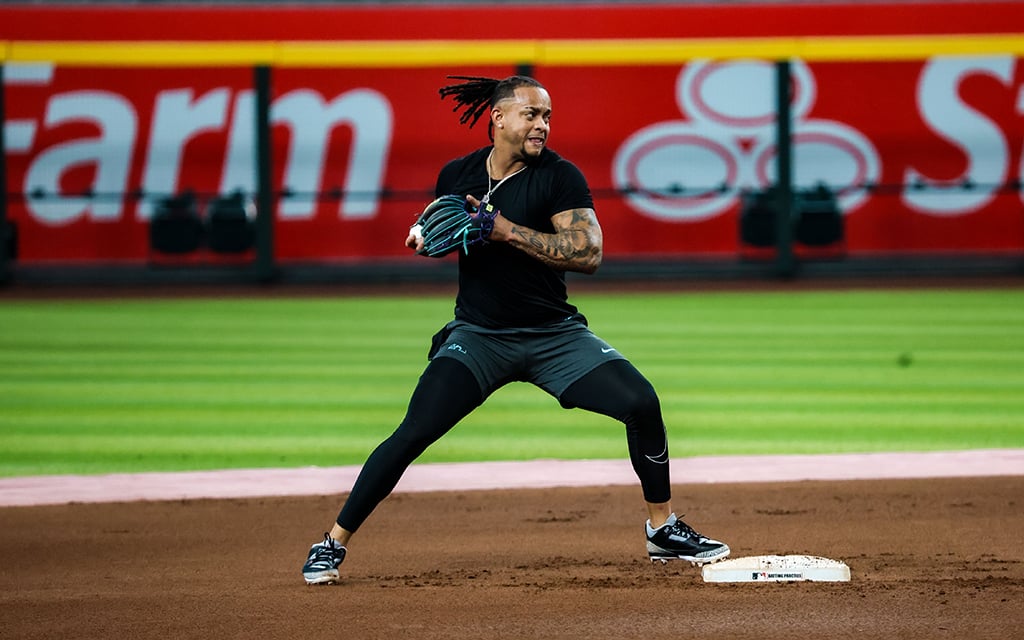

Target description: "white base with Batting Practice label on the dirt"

left=700, top=556, right=850, bottom=583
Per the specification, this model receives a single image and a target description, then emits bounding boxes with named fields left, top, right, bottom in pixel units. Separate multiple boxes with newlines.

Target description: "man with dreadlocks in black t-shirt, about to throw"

left=302, top=76, right=729, bottom=584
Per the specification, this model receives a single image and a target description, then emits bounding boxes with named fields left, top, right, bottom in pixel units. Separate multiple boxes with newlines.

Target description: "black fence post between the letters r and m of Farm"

left=253, top=65, right=275, bottom=283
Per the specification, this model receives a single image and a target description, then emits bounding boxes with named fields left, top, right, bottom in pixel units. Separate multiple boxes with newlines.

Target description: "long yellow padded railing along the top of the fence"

left=6, top=34, right=1024, bottom=68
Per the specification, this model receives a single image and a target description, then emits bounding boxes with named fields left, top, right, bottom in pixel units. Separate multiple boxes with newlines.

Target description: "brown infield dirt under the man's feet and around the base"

left=0, top=475, right=1024, bottom=640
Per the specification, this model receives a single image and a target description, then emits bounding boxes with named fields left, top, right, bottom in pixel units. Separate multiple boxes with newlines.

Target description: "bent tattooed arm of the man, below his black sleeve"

left=508, top=209, right=602, bottom=273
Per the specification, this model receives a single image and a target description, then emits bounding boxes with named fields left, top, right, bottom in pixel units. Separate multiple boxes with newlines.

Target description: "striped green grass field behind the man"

left=0, top=290, right=1024, bottom=476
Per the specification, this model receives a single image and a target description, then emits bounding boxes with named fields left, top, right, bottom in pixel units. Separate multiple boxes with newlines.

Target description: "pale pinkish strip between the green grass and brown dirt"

left=0, top=449, right=1024, bottom=507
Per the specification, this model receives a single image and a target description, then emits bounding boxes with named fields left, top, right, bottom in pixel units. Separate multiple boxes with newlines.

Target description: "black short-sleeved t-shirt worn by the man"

left=435, top=146, right=594, bottom=328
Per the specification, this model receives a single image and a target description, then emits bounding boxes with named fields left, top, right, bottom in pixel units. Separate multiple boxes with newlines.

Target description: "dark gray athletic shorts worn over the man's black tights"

left=430, top=316, right=626, bottom=398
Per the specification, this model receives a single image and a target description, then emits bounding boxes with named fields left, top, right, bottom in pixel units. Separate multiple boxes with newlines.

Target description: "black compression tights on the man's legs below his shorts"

left=337, top=357, right=671, bottom=532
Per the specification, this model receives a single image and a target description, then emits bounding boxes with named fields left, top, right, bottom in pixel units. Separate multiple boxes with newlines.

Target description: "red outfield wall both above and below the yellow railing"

left=0, top=2, right=1024, bottom=263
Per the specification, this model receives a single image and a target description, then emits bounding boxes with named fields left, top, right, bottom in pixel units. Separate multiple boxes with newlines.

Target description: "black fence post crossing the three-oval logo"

left=775, top=60, right=797, bottom=278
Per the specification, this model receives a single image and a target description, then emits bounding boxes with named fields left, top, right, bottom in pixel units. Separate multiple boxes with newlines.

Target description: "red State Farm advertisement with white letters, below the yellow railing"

left=4, top=56, right=1024, bottom=263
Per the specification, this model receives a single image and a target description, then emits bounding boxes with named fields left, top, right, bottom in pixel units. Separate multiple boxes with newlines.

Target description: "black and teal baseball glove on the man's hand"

left=414, top=196, right=500, bottom=258
